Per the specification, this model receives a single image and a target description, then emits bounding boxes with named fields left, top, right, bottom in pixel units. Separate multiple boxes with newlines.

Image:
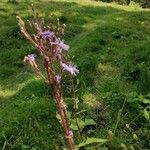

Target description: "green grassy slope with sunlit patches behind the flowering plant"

left=0, top=0, right=150, bottom=150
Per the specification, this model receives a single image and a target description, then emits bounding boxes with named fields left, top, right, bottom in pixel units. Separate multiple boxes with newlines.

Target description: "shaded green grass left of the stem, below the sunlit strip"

left=0, top=82, right=64, bottom=150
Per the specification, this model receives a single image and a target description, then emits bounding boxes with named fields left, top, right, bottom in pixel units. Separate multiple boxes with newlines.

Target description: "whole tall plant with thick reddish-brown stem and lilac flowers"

left=17, top=5, right=79, bottom=150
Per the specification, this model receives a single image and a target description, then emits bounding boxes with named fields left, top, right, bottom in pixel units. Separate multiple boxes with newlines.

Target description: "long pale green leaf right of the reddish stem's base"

left=77, top=138, right=108, bottom=148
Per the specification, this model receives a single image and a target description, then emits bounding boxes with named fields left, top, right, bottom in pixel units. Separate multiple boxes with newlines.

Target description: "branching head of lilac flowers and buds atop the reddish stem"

left=17, top=17, right=79, bottom=76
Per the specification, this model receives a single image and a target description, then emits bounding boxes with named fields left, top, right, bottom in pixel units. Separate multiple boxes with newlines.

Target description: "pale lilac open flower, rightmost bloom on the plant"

left=61, top=63, right=79, bottom=76
